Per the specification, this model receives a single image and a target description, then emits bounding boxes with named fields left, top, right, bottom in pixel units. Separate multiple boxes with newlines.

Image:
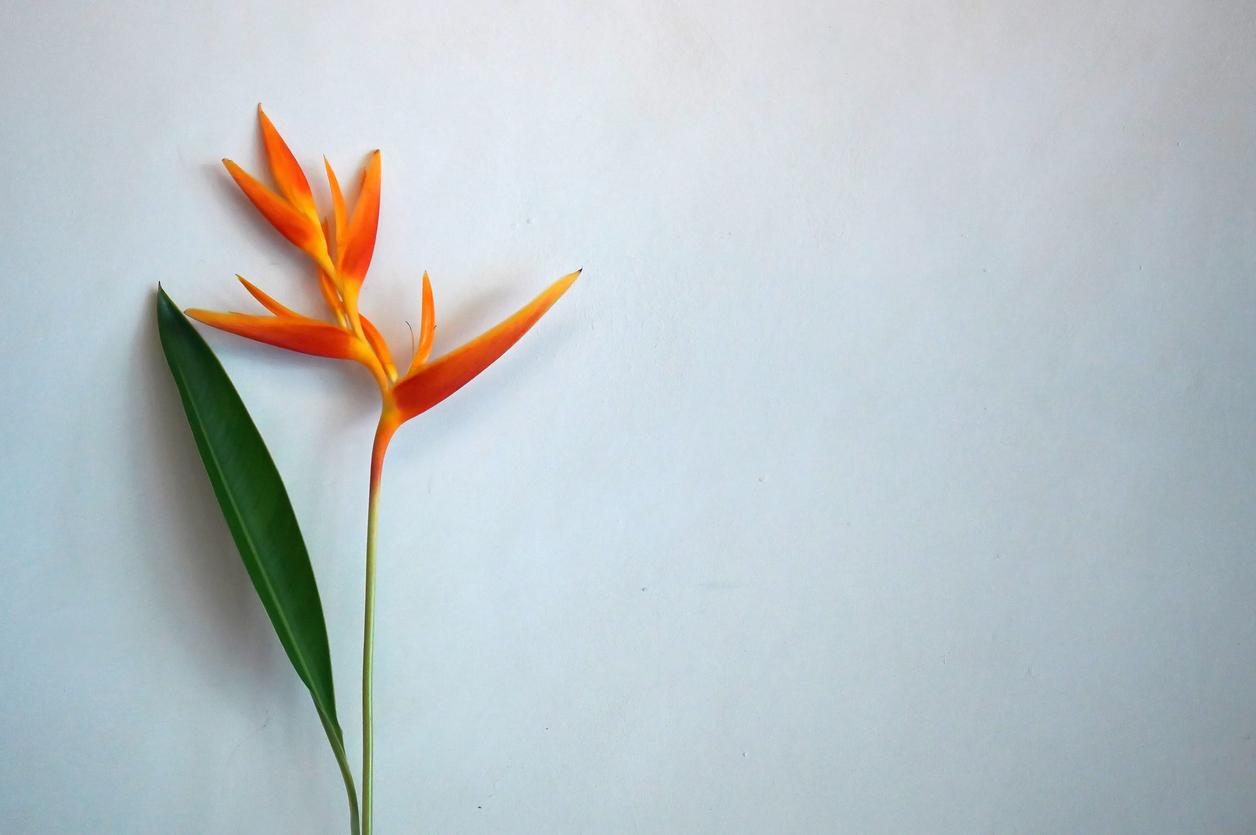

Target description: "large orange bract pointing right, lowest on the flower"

left=393, top=270, right=580, bottom=421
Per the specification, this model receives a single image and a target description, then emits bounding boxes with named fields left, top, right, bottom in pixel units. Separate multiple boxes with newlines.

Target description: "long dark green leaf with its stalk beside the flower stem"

left=157, top=286, right=358, bottom=832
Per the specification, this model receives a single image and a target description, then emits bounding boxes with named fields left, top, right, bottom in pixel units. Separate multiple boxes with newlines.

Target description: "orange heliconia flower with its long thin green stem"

left=186, top=105, right=580, bottom=835
